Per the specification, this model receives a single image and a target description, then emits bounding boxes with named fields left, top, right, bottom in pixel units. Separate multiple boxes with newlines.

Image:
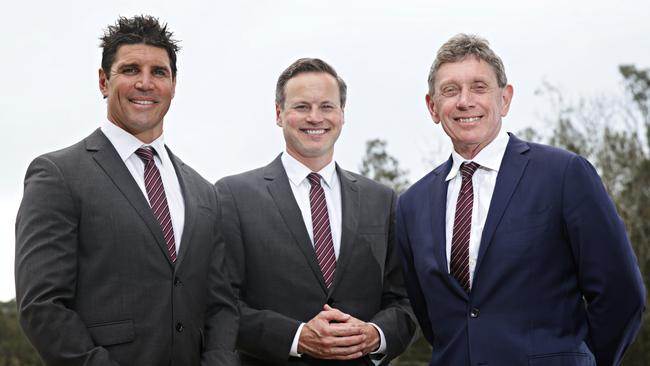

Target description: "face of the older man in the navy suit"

left=426, top=56, right=512, bottom=159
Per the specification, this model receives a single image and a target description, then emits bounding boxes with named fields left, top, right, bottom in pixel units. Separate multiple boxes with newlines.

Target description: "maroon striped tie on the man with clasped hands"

left=307, top=173, right=336, bottom=288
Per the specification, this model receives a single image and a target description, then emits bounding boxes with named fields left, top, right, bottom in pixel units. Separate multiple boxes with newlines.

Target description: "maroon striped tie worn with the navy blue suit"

left=450, top=162, right=479, bottom=293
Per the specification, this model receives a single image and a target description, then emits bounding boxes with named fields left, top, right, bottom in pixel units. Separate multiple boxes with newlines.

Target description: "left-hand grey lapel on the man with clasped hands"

left=264, top=156, right=326, bottom=293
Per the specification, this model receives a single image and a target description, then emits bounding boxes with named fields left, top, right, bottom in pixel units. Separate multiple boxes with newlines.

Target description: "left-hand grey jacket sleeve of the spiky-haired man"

left=15, top=157, right=117, bottom=366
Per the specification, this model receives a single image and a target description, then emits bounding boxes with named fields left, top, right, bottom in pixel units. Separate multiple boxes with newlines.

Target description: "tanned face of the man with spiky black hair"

left=99, top=44, right=176, bottom=142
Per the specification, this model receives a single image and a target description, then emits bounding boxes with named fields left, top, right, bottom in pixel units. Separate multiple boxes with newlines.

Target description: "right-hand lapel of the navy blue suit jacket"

left=474, top=135, right=529, bottom=279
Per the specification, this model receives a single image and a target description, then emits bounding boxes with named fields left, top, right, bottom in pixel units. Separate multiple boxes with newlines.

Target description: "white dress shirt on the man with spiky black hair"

left=101, top=121, right=185, bottom=253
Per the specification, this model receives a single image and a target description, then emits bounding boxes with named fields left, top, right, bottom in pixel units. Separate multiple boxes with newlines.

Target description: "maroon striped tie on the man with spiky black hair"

left=135, top=146, right=176, bottom=262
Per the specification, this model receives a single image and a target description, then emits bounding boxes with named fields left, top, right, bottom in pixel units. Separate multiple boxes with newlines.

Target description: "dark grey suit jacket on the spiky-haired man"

left=15, top=130, right=238, bottom=366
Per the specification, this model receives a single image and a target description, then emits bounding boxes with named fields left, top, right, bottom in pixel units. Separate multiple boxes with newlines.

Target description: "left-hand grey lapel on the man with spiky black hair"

left=86, top=129, right=172, bottom=265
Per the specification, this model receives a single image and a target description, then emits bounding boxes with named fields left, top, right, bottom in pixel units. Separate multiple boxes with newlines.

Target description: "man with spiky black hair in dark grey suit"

left=15, top=16, right=238, bottom=366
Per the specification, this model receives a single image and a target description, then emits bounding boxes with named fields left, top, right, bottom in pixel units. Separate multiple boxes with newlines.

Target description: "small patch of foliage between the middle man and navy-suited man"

left=359, top=139, right=409, bottom=194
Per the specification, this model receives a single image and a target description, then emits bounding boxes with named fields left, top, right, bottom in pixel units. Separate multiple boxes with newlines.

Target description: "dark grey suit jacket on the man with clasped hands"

left=217, top=157, right=415, bottom=365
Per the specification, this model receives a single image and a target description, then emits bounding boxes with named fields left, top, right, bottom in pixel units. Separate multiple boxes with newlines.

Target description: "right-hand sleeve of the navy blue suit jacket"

left=563, top=156, right=645, bottom=365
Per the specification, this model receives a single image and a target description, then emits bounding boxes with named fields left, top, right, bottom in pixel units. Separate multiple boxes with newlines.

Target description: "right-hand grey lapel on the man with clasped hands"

left=330, top=164, right=360, bottom=293
